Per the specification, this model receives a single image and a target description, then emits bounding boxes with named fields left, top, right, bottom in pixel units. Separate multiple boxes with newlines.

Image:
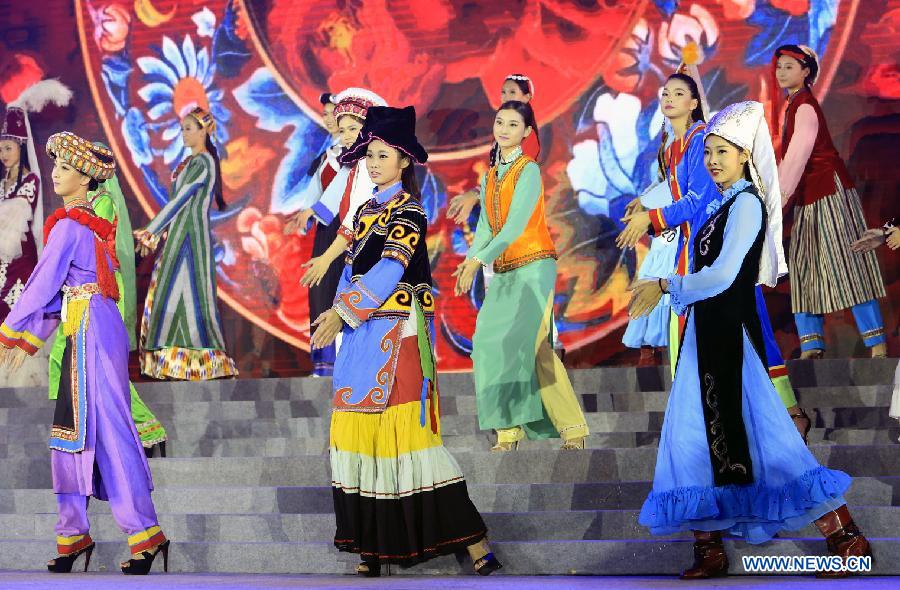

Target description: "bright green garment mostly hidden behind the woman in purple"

left=50, top=176, right=167, bottom=449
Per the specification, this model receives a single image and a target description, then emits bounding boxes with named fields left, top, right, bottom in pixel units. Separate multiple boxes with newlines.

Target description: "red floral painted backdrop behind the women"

left=0, top=0, right=900, bottom=370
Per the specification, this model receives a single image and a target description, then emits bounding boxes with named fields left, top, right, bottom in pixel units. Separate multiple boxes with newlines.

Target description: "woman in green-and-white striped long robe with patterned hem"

left=134, top=107, right=237, bottom=381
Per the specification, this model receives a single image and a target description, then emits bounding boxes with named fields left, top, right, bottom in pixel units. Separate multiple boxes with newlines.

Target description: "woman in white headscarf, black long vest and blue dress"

left=630, top=102, right=871, bottom=578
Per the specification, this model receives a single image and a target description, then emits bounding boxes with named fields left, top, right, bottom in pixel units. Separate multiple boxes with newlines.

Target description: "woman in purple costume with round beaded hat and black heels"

left=0, top=132, right=169, bottom=574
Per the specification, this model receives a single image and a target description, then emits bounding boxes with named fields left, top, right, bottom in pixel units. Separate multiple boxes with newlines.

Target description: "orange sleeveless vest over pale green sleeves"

left=484, top=155, right=556, bottom=272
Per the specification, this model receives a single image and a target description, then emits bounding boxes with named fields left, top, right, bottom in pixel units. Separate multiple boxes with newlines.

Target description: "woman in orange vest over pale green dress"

left=453, top=101, right=588, bottom=451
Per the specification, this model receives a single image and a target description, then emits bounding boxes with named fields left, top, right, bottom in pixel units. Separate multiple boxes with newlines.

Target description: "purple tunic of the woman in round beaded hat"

left=0, top=219, right=153, bottom=500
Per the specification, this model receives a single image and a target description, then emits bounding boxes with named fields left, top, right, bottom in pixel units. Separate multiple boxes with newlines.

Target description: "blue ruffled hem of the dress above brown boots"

left=638, top=465, right=853, bottom=544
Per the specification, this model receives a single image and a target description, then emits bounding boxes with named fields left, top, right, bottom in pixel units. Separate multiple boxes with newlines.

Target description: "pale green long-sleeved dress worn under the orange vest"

left=468, top=152, right=588, bottom=442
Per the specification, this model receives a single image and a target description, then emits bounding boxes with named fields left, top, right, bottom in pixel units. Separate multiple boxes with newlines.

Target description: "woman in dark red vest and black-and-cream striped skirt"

left=772, top=45, right=887, bottom=358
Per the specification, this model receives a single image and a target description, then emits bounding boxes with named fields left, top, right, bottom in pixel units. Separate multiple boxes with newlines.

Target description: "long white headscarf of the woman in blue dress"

left=706, top=101, right=788, bottom=287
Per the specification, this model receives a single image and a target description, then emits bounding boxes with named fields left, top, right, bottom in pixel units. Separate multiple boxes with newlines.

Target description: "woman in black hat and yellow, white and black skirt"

left=311, top=106, right=501, bottom=576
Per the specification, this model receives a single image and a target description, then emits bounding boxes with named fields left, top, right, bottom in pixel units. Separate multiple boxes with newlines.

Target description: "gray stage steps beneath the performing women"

left=0, top=359, right=900, bottom=574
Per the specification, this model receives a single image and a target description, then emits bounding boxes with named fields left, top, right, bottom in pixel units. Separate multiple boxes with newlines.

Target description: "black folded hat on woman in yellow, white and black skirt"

left=340, top=106, right=428, bottom=166
